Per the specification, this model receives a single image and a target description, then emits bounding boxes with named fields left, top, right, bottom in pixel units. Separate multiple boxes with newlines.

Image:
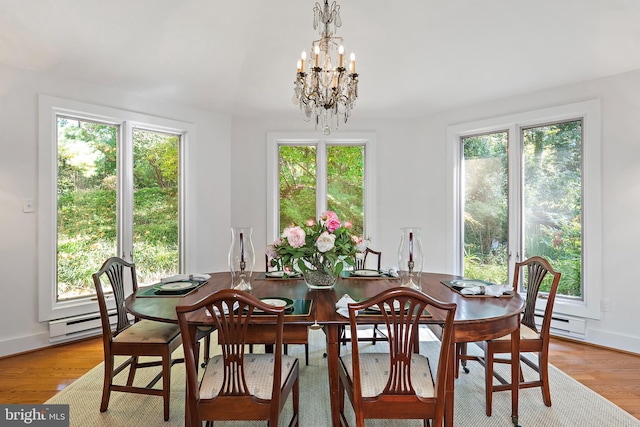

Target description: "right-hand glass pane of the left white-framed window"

left=133, top=129, right=180, bottom=284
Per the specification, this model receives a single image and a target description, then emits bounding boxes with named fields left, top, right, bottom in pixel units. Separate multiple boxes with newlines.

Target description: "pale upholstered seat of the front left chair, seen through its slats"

left=200, top=353, right=296, bottom=400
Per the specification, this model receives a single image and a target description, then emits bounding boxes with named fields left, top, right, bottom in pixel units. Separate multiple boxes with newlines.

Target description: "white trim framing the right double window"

left=446, top=100, right=602, bottom=319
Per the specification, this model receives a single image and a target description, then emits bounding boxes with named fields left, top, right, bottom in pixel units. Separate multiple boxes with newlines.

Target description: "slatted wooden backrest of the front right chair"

left=349, top=287, right=456, bottom=410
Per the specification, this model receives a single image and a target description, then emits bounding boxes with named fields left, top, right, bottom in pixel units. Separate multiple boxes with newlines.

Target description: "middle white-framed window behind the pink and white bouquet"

left=267, top=134, right=375, bottom=244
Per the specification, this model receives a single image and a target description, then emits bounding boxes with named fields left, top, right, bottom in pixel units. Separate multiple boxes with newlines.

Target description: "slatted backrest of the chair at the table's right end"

left=513, top=256, right=561, bottom=336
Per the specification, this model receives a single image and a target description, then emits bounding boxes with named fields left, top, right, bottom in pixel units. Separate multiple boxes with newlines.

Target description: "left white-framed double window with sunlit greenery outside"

left=39, top=96, right=186, bottom=320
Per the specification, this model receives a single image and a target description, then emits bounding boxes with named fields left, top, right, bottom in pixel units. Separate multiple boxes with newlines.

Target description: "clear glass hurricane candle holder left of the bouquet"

left=229, top=227, right=256, bottom=291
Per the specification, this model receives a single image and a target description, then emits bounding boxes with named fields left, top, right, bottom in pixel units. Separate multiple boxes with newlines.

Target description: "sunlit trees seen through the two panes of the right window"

left=462, top=120, right=583, bottom=298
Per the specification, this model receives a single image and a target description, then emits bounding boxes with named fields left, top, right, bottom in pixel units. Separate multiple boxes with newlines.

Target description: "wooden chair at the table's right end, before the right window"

left=456, top=256, right=561, bottom=416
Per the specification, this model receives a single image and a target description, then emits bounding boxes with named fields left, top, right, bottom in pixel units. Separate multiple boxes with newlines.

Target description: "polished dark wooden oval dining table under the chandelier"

left=125, top=272, right=524, bottom=426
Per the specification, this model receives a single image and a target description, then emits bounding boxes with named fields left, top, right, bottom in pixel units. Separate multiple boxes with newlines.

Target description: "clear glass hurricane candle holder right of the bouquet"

left=398, top=227, right=424, bottom=291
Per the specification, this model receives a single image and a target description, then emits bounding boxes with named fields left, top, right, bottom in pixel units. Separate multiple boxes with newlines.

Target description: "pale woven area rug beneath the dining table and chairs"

left=46, top=330, right=640, bottom=427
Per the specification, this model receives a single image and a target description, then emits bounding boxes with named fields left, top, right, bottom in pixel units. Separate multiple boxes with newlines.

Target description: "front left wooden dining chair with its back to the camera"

left=176, top=289, right=299, bottom=427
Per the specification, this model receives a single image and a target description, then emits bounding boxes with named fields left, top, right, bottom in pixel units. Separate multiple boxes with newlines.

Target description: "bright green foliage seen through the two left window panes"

left=56, top=116, right=180, bottom=301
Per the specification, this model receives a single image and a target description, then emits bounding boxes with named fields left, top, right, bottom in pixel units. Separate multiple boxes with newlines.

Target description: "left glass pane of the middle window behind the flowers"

left=278, top=145, right=316, bottom=234
